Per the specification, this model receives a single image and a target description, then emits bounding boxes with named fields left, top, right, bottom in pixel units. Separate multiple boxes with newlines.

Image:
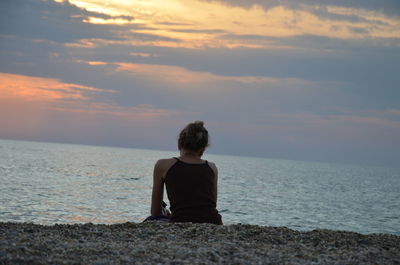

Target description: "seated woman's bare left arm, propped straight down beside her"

left=151, top=160, right=164, bottom=216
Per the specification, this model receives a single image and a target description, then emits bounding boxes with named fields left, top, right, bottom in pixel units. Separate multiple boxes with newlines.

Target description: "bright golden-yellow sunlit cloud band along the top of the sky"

left=64, top=0, right=400, bottom=48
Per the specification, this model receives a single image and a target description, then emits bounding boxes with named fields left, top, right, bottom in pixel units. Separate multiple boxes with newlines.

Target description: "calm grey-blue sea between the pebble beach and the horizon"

left=0, top=140, right=400, bottom=235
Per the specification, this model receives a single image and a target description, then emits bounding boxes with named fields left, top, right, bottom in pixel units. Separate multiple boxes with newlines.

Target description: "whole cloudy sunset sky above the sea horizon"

left=0, top=0, right=400, bottom=167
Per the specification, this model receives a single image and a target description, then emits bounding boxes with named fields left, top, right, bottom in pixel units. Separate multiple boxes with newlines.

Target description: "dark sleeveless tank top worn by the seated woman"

left=165, top=158, right=222, bottom=224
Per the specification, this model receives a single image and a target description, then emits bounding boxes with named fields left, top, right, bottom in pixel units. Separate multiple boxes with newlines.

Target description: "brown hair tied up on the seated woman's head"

left=178, top=121, right=209, bottom=151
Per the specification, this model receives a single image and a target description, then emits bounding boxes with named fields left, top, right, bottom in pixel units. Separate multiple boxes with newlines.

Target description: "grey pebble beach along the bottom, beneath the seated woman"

left=0, top=222, right=400, bottom=265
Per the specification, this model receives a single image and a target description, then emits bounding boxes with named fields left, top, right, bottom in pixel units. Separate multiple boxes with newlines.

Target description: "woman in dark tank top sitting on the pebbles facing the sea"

left=148, top=121, right=222, bottom=224
